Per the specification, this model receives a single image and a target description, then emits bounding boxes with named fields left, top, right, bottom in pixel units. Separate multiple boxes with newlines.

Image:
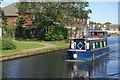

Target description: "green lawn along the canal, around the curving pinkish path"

left=0, top=41, right=69, bottom=57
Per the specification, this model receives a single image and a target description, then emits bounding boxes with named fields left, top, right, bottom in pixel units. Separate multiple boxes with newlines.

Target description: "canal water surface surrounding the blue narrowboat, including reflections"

left=2, top=36, right=120, bottom=79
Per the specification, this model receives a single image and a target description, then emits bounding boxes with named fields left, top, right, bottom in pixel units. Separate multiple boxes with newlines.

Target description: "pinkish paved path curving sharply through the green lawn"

left=20, top=42, right=57, bottom=51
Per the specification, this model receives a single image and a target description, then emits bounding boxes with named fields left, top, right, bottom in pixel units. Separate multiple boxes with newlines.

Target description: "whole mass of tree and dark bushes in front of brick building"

left=16, top=2, right=92, bottom=41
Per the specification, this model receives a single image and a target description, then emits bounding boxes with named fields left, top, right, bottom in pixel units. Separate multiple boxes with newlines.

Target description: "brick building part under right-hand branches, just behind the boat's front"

left=65, top=18, right=87, bottom=38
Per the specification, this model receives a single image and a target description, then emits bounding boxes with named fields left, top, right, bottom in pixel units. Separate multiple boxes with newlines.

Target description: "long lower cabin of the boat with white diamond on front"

left=69, top=38, right=107, bottom=51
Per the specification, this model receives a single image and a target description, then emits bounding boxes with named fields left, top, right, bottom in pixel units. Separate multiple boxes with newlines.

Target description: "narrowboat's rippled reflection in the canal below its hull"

left=68, top=54, right=109, bottom=78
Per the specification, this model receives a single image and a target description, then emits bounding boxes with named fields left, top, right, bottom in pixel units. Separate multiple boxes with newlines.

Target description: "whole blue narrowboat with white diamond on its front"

left=67, top=30, right=109, bottom=61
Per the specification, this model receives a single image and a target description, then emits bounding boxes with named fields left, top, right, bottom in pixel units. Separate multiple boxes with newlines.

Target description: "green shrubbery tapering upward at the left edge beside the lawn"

left=0, top=11, right=16, bottom=50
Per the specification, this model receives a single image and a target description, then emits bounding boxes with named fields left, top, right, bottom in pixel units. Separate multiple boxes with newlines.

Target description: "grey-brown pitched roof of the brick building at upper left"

left=2, top=3, right=18, bottom=16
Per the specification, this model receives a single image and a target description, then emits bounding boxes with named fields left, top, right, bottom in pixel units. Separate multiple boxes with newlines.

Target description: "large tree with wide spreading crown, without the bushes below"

left=17, top=2, right=91, bottom=40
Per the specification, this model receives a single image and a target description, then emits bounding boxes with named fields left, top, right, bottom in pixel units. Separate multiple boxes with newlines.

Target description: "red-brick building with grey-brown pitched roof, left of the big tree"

left=2, top=3, right=32, bottom=27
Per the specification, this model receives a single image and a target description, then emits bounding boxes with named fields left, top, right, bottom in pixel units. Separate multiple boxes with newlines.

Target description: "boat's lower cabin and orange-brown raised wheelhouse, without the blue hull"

left=69, top=30, right=107, bottom=50
